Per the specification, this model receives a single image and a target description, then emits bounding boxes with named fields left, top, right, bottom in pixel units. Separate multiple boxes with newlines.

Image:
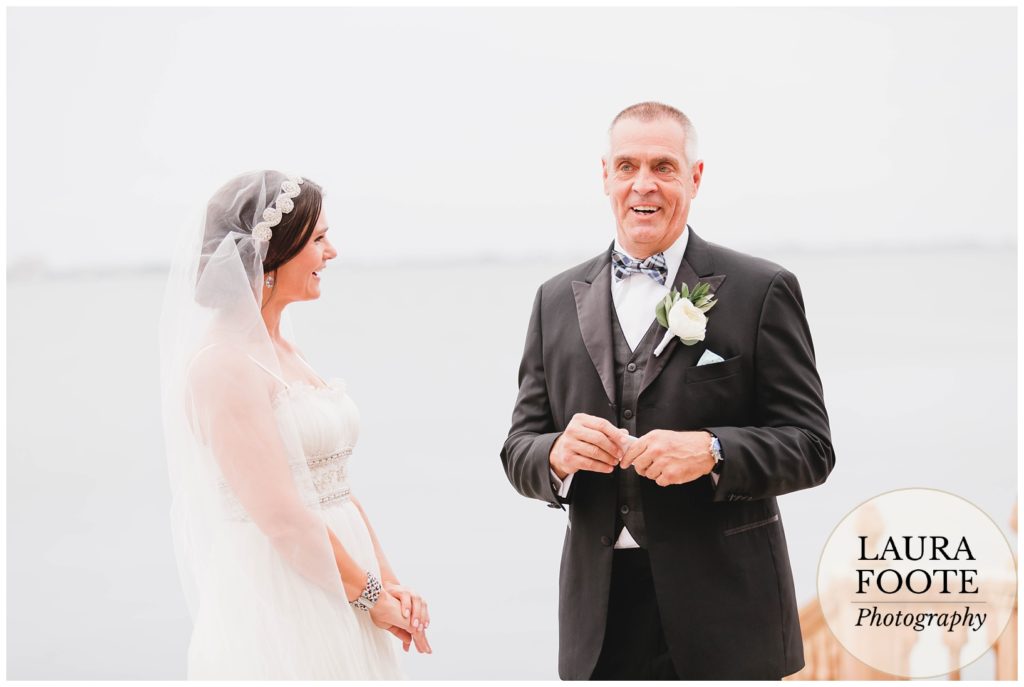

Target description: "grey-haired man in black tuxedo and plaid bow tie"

left=502, top=102, right=835, bottom=680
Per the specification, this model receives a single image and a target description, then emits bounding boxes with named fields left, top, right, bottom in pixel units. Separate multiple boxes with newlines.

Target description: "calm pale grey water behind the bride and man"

left=7, top=249, right=1017, bottom=679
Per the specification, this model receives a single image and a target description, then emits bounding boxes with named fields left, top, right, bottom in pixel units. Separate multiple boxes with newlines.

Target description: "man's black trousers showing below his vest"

left=590, top=549, right=679, bottom=680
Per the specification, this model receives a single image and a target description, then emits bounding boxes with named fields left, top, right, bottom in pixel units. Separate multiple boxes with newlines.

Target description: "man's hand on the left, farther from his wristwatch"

left=548, top=413, right=629, bottom=479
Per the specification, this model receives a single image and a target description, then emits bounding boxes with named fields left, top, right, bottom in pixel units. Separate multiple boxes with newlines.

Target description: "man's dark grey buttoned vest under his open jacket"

left=611, top=312, right=665, bottom=548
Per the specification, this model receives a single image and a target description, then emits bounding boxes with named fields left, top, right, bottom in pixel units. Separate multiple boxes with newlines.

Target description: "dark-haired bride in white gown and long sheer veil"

left=161, top=171, right=431, bottom=680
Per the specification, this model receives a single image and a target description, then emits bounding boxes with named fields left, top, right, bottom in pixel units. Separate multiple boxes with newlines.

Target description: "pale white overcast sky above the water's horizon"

left=7, top=8, right=1017, bottom=269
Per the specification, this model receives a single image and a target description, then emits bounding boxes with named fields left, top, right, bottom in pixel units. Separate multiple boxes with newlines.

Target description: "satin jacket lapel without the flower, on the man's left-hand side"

left=572, top=252, right=615, bottom=403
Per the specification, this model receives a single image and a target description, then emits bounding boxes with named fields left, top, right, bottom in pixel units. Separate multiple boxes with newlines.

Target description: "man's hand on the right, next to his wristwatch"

left=620, top=429, right=715, bottom=486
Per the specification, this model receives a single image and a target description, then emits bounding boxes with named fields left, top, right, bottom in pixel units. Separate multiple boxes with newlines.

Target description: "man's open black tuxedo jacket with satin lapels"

left=501, top=229, right=835, bottom=680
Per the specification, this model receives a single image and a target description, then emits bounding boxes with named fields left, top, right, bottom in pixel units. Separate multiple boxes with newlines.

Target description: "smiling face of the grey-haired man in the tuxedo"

left=601, top=118, right=703, bottom=259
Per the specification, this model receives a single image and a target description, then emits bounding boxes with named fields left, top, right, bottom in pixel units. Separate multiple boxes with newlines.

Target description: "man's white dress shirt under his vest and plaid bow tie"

left=551, top=227, right=690, bottom=549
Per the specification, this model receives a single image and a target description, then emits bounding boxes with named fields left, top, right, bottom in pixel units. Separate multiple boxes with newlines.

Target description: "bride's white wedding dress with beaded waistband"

left=188, top=363, right=404, bottom=680
